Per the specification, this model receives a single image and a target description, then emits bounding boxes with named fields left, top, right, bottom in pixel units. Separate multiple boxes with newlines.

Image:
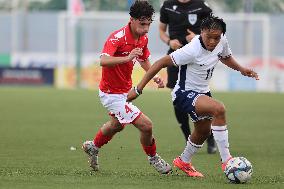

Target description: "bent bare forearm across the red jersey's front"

left=100, top=48, right=143, bottom=66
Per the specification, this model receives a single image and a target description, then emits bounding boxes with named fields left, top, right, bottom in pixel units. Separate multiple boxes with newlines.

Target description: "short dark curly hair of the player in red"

left=129, top=0, right=155, bottom=20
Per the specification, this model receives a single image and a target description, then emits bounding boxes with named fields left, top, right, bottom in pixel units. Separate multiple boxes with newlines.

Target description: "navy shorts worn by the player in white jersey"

left=173, top=90, right=213, bottom=122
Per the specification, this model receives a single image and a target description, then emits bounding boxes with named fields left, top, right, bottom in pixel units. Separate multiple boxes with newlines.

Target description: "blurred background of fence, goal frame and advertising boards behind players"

left=0, top=0, right=284, bottom=92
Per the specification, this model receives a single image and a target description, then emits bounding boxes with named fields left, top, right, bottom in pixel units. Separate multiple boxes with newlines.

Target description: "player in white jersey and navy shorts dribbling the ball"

left=128, top=15, right=258, bottom=177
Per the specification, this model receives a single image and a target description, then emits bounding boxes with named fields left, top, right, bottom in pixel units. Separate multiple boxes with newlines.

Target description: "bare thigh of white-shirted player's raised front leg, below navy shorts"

left=195, top=95, right=225, bottom=116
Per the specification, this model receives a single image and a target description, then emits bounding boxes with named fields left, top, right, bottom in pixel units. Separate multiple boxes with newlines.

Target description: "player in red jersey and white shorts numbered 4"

left=82, top=0, right=171, bottom=173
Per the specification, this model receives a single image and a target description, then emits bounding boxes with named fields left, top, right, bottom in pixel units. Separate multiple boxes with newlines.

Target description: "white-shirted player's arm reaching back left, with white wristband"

left=127, top=55, right=174, bottom=102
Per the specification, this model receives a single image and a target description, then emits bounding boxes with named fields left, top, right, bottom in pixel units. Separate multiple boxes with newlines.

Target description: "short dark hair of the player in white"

left=200, top=13, right=226, bottom=34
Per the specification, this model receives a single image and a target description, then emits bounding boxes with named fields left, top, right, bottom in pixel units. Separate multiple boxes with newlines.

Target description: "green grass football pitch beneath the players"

left=0, top=87, right=284, bottom=189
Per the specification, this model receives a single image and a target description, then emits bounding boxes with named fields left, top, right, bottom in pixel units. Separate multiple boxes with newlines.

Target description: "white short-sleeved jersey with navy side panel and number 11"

left=170, top=35, right=232, bottom=94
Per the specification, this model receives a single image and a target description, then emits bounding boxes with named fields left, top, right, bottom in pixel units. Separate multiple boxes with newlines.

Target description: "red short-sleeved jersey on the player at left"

left=99, top=24, right=150, bottom=94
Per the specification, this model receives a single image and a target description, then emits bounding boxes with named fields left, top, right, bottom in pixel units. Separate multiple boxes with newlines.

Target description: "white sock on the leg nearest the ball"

left=211, top=125, right=232, bottom=163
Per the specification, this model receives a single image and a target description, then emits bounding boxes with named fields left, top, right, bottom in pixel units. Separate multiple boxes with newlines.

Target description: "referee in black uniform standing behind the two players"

left=159, top=0, right=217, bottom=154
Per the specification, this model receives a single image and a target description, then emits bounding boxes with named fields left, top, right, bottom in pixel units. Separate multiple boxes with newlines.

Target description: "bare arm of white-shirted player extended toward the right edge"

left=220, top=56, right=259, bottom=80
